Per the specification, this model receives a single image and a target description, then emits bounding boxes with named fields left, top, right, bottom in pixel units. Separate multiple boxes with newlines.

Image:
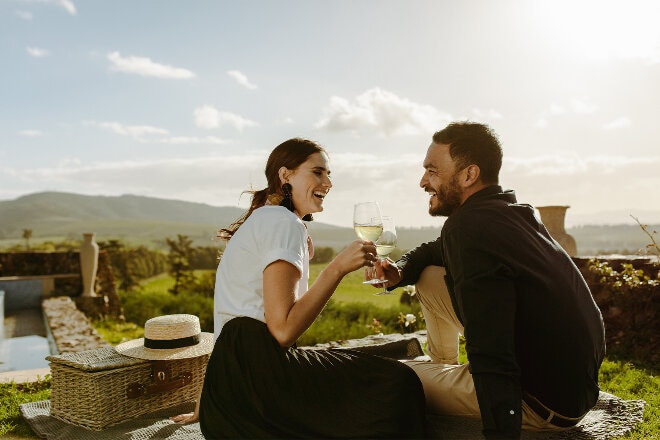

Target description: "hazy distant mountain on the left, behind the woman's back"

left=0, top=192, right=243, bottom=248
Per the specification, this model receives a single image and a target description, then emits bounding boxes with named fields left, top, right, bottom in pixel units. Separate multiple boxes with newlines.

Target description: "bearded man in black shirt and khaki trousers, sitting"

left=382, top=122, right=605, bottom=439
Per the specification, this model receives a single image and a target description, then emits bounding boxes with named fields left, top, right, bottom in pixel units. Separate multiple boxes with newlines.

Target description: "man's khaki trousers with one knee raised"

left=405, top=266, right=565, bottom=430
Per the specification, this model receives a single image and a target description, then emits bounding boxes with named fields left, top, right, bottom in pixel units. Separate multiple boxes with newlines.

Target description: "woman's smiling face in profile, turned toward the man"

left=287, top=152, right=332, bottom=218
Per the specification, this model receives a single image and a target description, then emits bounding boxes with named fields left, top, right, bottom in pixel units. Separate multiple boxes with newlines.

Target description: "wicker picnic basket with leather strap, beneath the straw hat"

left=46, top=347, right=209, bottom=431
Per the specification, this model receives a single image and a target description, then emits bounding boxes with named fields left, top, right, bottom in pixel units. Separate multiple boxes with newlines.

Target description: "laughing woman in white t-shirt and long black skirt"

left=174, top=138, right=425, bottom=439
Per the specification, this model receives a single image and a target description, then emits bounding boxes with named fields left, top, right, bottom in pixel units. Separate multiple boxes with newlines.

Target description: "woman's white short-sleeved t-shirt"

left=213, top=205, right=309, bottom=339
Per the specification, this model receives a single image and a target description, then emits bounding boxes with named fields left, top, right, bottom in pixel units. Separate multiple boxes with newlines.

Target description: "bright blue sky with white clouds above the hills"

left=0, top=0, right=660, bottom=227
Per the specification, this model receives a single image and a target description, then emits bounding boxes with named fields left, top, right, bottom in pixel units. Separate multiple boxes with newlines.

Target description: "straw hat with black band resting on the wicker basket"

left=115, top=314, right=213, bottom=360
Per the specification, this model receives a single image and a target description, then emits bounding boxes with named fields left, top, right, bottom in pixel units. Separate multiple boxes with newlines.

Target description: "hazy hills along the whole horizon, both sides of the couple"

left=0, top=192, right=660, bottom=255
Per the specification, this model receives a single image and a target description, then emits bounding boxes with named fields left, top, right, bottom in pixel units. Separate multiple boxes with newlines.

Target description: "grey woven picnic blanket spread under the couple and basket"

left=20, top=392, right=645, bottom=440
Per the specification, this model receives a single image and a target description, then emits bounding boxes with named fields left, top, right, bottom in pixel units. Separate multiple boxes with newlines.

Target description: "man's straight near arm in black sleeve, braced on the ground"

left=446, top=228, right=522, bottom=439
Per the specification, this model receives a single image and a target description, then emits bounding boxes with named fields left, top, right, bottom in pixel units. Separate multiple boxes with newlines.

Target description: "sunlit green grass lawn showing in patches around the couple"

left=0, top=265, right=660, bottom=440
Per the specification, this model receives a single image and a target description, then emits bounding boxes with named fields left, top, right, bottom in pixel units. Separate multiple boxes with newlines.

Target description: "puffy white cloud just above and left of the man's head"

left=315, top=87, right=451, bottom=136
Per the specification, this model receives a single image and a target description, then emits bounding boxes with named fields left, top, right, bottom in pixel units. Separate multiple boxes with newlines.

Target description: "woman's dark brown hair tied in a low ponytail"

left=218, top=138, right=325, bottom=240
